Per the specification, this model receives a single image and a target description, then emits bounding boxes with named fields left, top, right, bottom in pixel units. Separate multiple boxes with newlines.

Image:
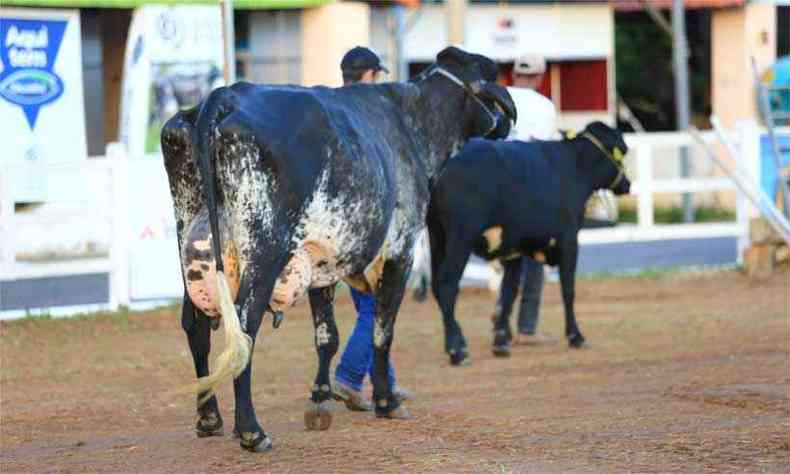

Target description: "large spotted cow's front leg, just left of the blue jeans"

left=304, top=285, right=339, bottom=431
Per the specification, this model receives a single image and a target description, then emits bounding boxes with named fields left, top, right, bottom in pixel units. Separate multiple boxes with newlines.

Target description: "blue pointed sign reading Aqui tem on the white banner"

left=0, top=18, right=68, bottom=130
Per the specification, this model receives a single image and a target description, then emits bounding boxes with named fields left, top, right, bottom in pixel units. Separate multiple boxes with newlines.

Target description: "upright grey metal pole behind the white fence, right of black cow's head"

left=672, top=0, right=694, bottom=222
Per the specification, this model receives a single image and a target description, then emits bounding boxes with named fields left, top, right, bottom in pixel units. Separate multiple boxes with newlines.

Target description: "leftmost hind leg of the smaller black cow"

left=433, top=242, right=471, bottom=365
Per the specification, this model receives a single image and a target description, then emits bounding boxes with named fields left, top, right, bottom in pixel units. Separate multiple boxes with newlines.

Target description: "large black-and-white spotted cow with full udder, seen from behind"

left=162, top=48, right=516, bottom=451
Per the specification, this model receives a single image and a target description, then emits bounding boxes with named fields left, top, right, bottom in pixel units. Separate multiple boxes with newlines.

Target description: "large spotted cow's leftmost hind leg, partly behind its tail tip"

left=181, top=295, right=222, bottom=438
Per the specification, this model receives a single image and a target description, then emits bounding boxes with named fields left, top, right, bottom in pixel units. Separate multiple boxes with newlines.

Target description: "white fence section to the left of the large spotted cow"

left=0, top=144, right=183, bottom=319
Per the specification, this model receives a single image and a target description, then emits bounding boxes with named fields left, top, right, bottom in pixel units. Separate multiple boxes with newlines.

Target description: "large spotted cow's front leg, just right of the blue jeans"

left=372, top=255, right=411, bottom=419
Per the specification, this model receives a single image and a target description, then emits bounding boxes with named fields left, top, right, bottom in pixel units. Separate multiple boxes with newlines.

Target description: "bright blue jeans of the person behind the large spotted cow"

left=335, top=288, right=395, bottom=390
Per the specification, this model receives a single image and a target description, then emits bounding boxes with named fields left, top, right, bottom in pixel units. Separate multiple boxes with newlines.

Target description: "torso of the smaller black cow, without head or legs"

left=431, top=140, right=573, bottom=258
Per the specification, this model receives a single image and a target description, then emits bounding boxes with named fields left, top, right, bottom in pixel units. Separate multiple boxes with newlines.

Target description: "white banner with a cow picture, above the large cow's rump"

left=120, top=5, right=223, bottom=158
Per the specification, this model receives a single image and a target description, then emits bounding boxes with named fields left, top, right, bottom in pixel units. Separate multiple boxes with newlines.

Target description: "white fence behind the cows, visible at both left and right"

left=0, top=125, right=760, bottom=319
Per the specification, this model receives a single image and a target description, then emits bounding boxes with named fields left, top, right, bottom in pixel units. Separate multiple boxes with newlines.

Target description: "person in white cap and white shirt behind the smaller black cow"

left=490, top=54, right=559, bottom=345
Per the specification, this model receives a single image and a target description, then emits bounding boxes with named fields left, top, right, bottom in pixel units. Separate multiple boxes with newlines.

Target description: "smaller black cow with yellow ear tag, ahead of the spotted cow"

left=428, top=122, right=630, bottom=365
